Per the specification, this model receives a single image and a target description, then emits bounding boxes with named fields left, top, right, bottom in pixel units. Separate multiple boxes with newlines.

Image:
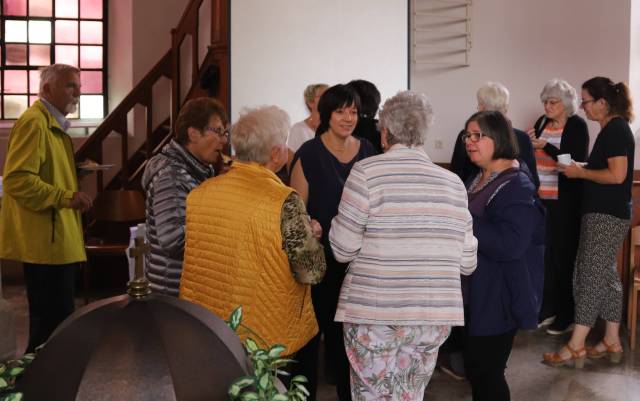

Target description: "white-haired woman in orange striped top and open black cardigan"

left=529, top=78, right=589, bottom=335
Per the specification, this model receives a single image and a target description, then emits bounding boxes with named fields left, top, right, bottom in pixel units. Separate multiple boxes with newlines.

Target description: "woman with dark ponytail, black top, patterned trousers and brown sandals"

left=544, top=77, right=635, bottom=368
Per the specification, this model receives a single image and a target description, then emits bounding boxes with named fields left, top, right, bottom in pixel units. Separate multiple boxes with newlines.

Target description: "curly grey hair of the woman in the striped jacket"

left=380, top=91, right=433, bottom=146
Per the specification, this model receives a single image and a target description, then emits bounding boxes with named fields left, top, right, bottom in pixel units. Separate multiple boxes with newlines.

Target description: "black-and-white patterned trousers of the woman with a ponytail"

left=573, top=213, right=629, bottom=327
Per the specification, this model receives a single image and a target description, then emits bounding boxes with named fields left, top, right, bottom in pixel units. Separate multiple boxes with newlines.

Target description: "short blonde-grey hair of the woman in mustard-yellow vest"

left=231, top=106, right=290, bottom=165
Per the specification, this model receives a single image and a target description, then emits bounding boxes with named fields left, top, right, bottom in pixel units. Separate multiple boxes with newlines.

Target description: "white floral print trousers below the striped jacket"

left=344, top=323, right=451, bottom=401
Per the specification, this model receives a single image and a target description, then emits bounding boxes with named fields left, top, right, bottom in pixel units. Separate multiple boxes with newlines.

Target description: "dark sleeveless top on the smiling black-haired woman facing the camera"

left=292, top=136, right=377, bottom=245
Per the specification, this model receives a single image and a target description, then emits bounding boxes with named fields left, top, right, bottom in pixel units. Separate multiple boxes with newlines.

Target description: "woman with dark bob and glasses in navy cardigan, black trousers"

left=462, top=111, right=544, bottom=401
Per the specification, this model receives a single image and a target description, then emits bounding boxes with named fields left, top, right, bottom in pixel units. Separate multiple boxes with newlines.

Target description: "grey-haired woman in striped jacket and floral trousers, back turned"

left=329, top=91, right=477, bottom=401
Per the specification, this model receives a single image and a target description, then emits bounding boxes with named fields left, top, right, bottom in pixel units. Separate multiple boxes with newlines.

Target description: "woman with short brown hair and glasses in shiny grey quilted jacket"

left=142, top=97, right=228, bottom=297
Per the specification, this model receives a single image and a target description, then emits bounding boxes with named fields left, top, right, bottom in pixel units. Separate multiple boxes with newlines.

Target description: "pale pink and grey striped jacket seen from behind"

left=329, top=145, right=478, bottom=326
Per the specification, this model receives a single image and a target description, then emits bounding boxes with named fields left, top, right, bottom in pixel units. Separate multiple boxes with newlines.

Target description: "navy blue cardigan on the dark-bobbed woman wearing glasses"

left=464, top=171, right=545, bottom=336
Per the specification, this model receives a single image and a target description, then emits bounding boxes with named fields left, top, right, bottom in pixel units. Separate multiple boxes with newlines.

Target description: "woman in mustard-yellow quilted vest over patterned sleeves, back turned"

left=180, top=106, right=326, bottom=354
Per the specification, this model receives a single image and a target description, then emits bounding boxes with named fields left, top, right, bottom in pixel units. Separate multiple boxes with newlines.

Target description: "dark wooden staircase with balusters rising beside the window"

left=76, top=0, right=230, bottom=193
